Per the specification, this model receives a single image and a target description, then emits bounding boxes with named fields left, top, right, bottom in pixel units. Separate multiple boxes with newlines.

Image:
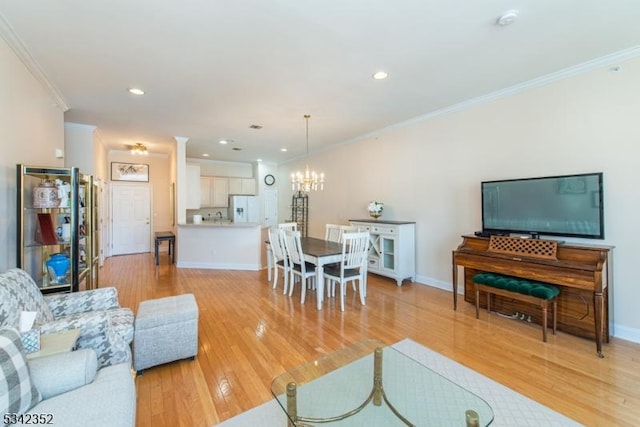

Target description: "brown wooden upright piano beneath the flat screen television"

left=452, top=236, right=613, bottom=357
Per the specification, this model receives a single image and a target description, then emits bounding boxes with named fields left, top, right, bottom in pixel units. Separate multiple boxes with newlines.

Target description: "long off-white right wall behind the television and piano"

left=278, top=58, right=640, bottom=341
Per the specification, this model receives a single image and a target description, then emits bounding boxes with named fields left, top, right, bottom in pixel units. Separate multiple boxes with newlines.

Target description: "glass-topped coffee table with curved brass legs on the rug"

left=271, top=340, right=493, bottom=427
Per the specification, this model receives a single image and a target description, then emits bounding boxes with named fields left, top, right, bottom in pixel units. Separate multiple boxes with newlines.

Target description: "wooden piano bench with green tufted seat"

left=473, top=273, right=560, bottom=342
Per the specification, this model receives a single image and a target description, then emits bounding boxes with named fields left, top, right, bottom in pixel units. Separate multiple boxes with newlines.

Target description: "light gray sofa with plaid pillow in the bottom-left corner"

left=0, top=328, right=136, bottom=427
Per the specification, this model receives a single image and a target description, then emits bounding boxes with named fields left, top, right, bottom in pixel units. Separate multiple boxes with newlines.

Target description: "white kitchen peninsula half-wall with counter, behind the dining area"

left=176, top=221, right=264, bottom=271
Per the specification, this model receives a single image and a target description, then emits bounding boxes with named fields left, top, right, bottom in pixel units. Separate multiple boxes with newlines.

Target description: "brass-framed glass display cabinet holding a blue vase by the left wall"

left=16, top=164, right=98, bottom=293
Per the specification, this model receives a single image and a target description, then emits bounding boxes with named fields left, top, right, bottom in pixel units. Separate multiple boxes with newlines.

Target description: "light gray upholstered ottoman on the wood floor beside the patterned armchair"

left=133, top=294, right=198, bottom=373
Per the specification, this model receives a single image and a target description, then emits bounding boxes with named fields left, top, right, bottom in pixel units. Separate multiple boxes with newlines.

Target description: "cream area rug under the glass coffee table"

left=219, top=339, right=580, bottom=427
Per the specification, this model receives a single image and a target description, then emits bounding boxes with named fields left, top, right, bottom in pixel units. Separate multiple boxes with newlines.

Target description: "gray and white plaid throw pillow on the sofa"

left=0, top=328, right=42, bottom=419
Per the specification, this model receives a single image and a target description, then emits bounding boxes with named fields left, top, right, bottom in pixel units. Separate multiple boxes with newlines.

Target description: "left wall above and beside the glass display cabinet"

left=0, top=37, right=64, bottom=271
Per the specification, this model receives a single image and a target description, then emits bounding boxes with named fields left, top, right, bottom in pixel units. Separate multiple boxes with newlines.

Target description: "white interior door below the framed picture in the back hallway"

left=111, top=184, right=151, bottom=255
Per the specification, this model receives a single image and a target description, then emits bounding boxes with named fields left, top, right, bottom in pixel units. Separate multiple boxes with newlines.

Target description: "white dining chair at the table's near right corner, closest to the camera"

left=324, top=232, right=369, bottom=311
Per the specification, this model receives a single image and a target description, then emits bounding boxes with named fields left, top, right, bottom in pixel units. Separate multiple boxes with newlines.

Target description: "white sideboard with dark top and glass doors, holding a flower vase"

left=349, top=219, right=416, bottom=286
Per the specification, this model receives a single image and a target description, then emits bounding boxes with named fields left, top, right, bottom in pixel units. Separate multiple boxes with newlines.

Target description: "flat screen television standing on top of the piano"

left=481, top=172, right=604, bottom=239
